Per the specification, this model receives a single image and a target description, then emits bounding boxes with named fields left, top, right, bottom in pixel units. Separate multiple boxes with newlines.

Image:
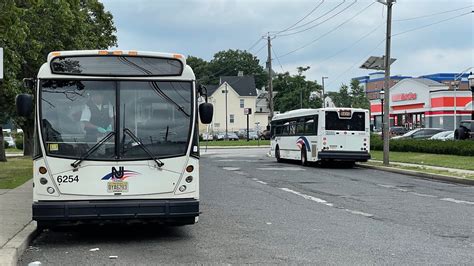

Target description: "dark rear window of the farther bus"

left=326, top=111, right=365, bottom=131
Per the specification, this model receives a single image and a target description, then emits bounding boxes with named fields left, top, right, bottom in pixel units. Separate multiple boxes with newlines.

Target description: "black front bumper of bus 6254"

left=33, top=199, right=199, bottom=224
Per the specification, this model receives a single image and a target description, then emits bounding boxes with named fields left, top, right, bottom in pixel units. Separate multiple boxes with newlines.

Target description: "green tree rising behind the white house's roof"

left=208, top=49, right=268, bottom=88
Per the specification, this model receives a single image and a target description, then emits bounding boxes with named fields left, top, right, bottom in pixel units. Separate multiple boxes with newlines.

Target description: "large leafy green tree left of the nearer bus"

left=0, top=0, right=117, bottom=158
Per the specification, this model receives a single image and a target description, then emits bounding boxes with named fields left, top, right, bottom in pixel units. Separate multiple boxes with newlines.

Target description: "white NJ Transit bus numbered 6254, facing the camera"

left=16, top=50, right=213, bottom=228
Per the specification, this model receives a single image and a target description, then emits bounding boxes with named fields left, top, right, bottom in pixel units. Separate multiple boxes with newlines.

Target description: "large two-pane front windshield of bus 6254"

left=40, top=80, right=193, bottom=160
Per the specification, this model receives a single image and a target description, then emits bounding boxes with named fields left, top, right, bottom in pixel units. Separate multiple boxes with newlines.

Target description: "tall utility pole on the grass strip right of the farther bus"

left=378, top=0, right=395, bottom=166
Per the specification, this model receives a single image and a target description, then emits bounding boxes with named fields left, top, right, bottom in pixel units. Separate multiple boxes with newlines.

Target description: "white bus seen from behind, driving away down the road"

left=271, top=108, right=370, bottom=165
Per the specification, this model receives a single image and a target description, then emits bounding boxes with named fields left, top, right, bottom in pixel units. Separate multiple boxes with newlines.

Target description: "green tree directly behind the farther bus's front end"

left=273, top=67, right=322, bottom=112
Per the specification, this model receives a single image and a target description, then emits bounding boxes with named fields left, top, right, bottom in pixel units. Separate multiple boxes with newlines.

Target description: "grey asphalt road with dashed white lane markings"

left=20, top=149, right=474, bottom=265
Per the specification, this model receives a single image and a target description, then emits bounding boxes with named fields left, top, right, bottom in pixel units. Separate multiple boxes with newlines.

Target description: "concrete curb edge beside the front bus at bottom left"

left=0, top=221, right=37, bottom=266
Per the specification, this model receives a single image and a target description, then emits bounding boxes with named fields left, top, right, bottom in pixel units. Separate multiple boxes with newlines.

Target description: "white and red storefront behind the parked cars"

left=370, top=78, right=472, bottom=130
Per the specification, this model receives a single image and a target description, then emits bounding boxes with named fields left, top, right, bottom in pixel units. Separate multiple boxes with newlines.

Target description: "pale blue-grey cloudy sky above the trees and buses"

left=102, top=0, right=474, bottom=90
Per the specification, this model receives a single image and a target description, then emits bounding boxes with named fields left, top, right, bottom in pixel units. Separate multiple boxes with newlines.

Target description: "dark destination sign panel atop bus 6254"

left=51, top=56, right=183, bottom=77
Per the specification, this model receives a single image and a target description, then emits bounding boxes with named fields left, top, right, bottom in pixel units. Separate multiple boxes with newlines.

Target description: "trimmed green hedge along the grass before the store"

left=370, top=135, right=474, bottom=156
